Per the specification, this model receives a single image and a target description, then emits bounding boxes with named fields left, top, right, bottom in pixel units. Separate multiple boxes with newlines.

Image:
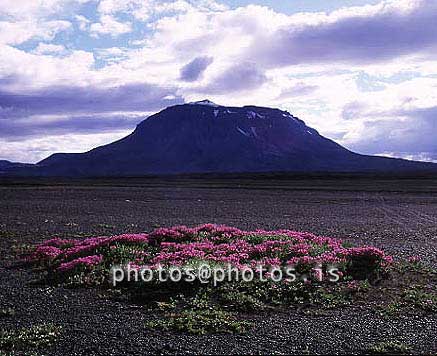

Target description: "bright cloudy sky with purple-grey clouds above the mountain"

left=0, top=0, right=437, bottom=163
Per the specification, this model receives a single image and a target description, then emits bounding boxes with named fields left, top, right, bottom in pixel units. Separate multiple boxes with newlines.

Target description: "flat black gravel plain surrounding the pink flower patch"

left=0, top=177, right=437, bottom=355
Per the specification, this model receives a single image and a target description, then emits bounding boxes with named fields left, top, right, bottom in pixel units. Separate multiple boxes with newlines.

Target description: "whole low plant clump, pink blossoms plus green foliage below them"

left=22, top=224, right=392, bottom=334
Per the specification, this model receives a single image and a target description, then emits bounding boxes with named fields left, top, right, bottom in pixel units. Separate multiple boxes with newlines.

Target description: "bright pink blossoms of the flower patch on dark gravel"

left=26, top=224, right=392, bottom=280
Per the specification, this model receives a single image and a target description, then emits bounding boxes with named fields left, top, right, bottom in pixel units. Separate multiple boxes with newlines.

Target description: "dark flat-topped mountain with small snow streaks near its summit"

left=3, top=100, right=437, bottom=176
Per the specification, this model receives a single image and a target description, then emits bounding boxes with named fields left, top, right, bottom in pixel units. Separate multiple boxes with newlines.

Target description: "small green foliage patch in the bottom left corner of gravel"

left=0, top=324, right=61, bottom=351
